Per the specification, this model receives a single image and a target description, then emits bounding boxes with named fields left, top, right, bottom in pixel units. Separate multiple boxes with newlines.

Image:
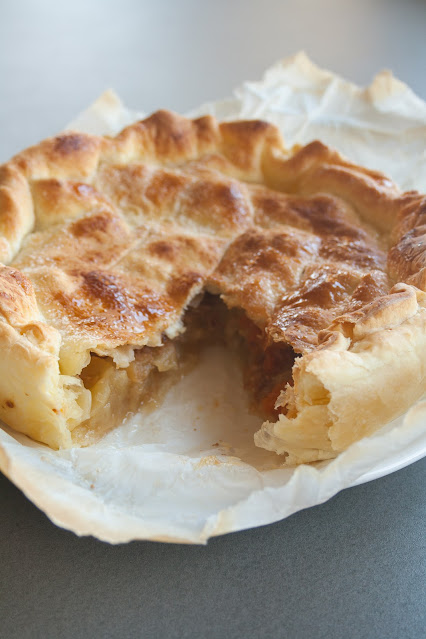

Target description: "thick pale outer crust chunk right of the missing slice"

left=255, top=283, right=426, bottom=464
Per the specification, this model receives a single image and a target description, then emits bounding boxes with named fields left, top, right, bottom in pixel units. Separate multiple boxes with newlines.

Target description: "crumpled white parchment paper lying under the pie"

left=0, top=53, right=426, bottom=543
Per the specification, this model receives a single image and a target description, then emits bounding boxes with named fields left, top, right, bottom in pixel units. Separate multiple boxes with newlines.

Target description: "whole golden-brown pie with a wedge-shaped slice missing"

left=0, top=111, right=426, bottom=463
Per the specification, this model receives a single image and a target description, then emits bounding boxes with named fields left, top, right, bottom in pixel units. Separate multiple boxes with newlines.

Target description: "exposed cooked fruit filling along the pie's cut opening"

left=72, top=293, right=296, bottom=445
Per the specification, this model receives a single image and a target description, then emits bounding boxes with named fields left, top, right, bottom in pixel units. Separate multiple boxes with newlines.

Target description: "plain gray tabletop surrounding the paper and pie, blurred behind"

left=0, top=0, right=426, bottom=639
